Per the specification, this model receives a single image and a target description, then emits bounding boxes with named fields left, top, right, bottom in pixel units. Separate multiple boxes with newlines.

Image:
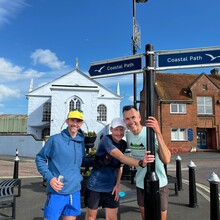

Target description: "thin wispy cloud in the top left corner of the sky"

left=0, top=0, right=27, bottom=27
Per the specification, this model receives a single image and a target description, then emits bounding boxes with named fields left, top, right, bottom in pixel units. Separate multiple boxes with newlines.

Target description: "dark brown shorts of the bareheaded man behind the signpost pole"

left=137, top=186, right=169, bottom=211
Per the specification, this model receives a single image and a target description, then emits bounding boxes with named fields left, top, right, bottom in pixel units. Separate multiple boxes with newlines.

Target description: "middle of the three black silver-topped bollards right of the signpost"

left=188, top=161, right=198, bottom=208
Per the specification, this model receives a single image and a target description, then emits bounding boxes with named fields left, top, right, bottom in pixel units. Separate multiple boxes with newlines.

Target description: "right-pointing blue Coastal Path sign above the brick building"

left=155, top=47, right=220, bottom=70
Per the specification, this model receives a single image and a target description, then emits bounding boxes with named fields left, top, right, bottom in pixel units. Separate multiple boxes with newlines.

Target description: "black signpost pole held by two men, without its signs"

left=144, top=44, right=161, bottom=220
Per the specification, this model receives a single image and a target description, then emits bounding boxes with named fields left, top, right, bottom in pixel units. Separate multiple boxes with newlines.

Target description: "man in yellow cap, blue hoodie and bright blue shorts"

left=36, top=110, right=85, bottom=220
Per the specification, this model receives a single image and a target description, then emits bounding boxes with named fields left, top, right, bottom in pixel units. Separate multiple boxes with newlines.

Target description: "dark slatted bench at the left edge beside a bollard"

left=0, top=179, right=21, bottom=219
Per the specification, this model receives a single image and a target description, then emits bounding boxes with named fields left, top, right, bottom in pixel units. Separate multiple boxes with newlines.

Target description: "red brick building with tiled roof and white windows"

left=140, top=68, right=220, bottom=152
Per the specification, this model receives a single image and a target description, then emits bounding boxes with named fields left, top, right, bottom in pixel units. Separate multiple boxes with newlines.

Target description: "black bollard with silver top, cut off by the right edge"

left=208, top=172, right=220, bottom=220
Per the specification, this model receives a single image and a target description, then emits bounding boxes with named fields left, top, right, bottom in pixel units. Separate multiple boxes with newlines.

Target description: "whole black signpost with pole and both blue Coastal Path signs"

left=89, top=44, right=220, bottom=220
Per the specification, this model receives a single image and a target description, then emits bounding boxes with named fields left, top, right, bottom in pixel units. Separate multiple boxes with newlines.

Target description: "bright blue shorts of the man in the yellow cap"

left=44, top=192, right=81, bottom=220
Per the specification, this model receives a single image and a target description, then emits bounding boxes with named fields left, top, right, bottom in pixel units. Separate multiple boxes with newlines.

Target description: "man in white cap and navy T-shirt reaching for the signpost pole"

left=85, top=118, right=154, bottom=220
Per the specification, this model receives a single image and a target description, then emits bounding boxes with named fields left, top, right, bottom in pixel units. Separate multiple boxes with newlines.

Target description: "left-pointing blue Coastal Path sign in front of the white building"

left=89, top=55, right=143, bottom=78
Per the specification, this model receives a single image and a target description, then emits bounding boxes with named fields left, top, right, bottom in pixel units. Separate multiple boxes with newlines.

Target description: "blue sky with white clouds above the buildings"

left=0, top=0, right=220, bottom=114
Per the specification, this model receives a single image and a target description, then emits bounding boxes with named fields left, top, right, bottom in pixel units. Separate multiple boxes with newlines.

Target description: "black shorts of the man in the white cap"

left=86, top=189, right=119, bottom=210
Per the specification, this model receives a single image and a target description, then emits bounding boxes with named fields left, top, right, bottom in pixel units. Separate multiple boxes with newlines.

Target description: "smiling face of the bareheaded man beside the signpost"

left=123, top=108, right=142, bottom=134
